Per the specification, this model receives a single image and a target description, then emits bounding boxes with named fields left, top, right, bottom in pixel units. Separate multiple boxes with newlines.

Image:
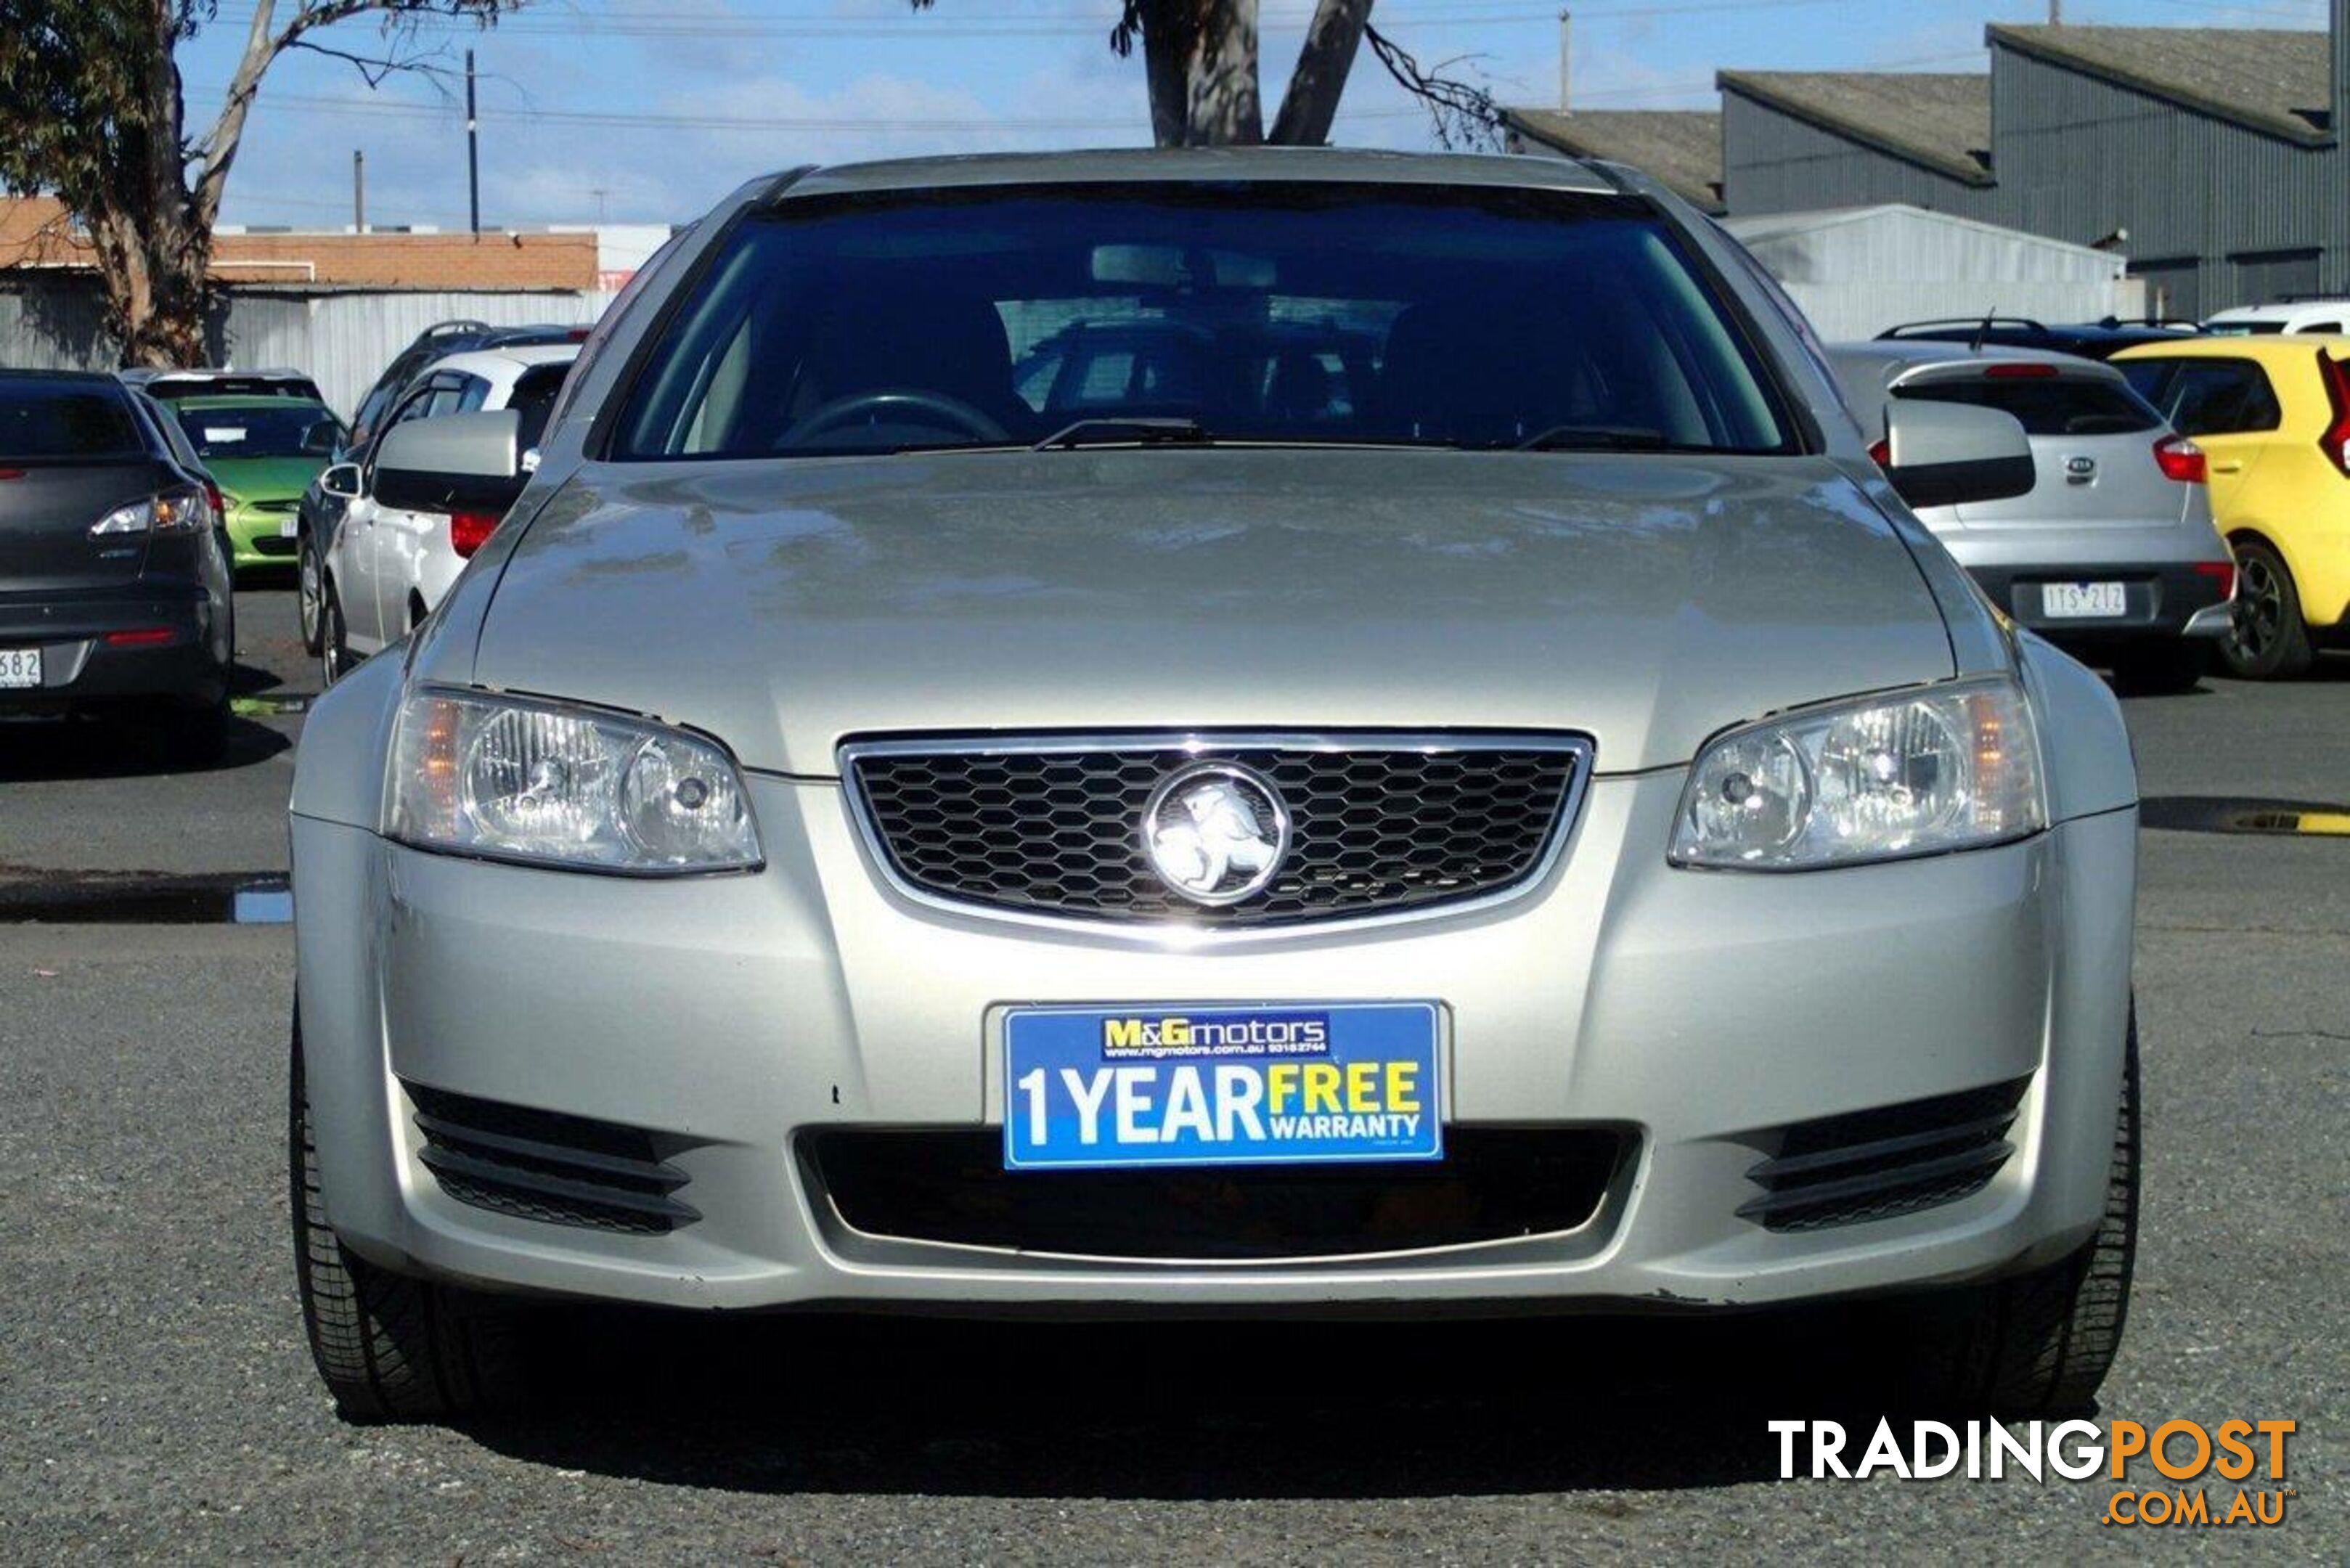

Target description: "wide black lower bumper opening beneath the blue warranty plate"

left=799, top=1126, right=1628, bottom=1262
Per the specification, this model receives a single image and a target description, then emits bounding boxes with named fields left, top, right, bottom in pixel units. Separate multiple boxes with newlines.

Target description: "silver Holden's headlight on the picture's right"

left=1673, top=679, right=2047, bottom=870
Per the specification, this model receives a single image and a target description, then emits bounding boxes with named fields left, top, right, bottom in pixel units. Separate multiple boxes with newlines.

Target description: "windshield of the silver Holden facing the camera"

left=613, top=181, right=1793, bottom=458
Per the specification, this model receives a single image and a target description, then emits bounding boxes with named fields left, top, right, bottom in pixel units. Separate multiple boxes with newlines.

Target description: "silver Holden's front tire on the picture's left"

left=287, top=1018, right=522, bottom=1422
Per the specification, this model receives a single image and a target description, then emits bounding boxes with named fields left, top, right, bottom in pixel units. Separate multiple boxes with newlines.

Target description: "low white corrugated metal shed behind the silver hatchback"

left=1723, top=205, right=2143, bottom=341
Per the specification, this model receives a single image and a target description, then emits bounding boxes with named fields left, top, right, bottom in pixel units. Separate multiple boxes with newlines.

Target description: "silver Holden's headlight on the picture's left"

left=390, top=691, right=759, bottom=875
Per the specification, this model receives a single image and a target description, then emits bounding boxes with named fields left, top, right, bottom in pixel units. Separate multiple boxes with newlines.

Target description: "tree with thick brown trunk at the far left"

left=0, top=0, right=524, bottom=364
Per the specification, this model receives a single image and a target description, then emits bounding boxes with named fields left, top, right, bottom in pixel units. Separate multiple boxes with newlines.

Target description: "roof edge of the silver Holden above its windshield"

left=778, top=148, right=1617, bottom=200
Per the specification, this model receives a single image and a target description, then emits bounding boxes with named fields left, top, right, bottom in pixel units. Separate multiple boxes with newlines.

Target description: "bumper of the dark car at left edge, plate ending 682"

left=0, top=581, right=228, bottom=712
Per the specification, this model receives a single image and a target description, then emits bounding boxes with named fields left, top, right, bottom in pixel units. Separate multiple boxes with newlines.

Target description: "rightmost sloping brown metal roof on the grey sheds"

left=1986, top=23, right=2333, bottom=146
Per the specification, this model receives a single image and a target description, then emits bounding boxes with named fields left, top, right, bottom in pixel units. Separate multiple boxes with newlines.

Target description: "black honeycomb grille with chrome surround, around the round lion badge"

left=844, top=733, right=1591, bottom=931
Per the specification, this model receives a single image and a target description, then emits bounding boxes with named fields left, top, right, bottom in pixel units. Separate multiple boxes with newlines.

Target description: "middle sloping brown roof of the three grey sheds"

left=1715, top=70, right=1991, bottom=186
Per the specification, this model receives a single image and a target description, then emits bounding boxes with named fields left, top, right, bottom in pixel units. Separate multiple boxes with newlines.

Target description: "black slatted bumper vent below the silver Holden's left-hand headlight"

left=404, top=1084, right=703, bottom=1236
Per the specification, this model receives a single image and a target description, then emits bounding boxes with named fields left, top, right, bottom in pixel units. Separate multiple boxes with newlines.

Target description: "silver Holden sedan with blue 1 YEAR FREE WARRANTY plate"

left=289, top=148, right=2139, bottom=1418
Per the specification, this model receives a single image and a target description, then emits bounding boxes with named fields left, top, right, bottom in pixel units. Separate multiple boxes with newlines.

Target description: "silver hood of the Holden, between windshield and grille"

left=458, top=449, right=1953, bottom=776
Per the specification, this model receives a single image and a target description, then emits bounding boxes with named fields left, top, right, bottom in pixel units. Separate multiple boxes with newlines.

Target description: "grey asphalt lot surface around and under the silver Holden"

left=0, top=590, right=2350, bottom=1564
